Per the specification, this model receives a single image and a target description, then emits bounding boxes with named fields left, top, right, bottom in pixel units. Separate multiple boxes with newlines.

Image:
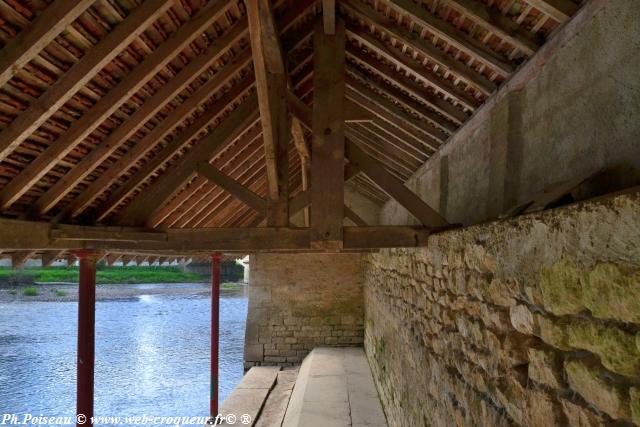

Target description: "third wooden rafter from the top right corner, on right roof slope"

left=381, top=0, right=515, bottom=76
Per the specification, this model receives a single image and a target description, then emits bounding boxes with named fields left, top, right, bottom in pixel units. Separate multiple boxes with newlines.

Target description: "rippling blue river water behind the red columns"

left=0, top=285, right=247, bottom=417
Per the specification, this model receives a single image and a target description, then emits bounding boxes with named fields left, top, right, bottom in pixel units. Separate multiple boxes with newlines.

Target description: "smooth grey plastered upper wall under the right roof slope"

left=381, top=0, right=640, bottom=225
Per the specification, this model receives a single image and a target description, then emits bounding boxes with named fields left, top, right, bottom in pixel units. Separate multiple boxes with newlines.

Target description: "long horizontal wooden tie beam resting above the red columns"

left=0, top=219, right=430, bottom=252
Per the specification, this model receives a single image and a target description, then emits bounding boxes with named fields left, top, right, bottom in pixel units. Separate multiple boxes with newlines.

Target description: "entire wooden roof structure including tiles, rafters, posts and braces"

left=0, top=0, right=581, bottom=263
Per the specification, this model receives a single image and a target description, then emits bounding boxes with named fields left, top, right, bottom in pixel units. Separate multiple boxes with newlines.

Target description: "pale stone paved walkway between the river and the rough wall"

left=220, top=347, right=387, bottom=427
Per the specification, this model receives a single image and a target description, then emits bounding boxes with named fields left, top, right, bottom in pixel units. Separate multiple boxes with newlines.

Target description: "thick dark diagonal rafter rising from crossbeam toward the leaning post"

left=118, top=95, right=258, bottom=227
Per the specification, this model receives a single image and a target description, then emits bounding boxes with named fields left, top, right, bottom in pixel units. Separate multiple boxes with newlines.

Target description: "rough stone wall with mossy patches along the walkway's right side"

left=363, top=191, right=640, bottom=427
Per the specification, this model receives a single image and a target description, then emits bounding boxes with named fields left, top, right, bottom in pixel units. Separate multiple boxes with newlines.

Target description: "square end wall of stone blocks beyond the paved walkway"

left=244, top=254, right=364, bottom=368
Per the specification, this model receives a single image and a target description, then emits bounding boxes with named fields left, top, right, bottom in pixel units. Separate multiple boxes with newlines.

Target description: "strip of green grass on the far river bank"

left=0, top=266, right=207, bottom=284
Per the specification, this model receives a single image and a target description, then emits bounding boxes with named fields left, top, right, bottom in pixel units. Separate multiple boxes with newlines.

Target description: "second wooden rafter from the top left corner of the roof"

left=0, top=0, right=173, bottom=160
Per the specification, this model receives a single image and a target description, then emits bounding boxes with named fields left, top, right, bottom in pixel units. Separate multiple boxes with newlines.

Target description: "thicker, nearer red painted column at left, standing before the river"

left=75, top=251, right=97, bottom=427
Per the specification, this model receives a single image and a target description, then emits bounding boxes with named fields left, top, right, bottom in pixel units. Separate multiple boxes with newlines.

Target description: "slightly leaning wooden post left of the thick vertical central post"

left=245, top=0, right=290, bottom=226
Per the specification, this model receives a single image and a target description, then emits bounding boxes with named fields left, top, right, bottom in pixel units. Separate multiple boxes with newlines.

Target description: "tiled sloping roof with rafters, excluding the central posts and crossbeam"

left=0, top=0, right=580, bottom=262
